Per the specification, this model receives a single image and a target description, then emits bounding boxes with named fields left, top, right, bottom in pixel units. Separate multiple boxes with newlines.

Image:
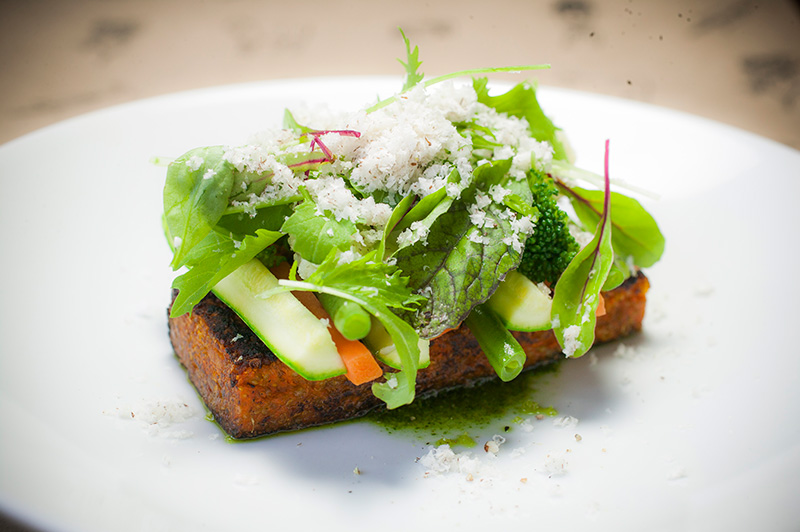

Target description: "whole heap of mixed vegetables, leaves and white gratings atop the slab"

left=164, top=34, right=664, bottom=408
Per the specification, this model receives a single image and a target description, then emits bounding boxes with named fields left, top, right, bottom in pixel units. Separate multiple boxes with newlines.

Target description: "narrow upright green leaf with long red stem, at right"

left=551, top=141, right=614, bottom=357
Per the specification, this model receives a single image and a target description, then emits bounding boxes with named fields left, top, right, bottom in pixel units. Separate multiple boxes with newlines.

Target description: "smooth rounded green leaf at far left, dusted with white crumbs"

left=164, top=146, right=234, bottom=270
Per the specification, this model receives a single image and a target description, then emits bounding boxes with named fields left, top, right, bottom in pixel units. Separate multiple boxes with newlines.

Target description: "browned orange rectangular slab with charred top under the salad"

left=169, top=273, right=649, bottom=438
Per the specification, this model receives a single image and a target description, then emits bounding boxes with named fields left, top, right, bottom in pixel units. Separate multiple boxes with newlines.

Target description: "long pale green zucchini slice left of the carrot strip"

left=213, top=259, right=347, bottom=380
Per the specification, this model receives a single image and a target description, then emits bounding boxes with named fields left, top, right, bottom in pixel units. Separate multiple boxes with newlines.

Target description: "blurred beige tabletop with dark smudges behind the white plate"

left=0, top=0, right=800, bottom=531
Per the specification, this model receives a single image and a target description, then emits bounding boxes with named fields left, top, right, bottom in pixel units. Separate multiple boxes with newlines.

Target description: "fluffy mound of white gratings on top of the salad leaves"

left=219, top=82, right=552, bottom=264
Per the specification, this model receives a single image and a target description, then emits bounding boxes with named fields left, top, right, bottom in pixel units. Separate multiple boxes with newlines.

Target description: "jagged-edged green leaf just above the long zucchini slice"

left=170, top=229, right=283, bottom=318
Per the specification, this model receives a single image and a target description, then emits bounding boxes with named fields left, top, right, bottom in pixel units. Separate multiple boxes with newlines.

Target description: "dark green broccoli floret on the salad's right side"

left=518, top=172, right=580, bottom=285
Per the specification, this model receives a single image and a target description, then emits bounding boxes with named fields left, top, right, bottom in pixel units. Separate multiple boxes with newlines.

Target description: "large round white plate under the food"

left=0, top=78, right=800, bottom=532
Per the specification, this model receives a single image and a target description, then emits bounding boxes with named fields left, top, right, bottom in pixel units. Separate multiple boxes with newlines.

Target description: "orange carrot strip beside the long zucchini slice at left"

left=272, top=263, right=383, bottom=386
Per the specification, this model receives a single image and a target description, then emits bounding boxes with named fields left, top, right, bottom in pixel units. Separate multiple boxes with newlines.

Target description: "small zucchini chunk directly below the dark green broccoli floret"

left=486, top=271, right=553, bottom=332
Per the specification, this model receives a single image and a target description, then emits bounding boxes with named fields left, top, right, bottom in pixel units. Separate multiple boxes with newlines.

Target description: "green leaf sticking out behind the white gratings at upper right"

left=472, top=78, right=567, bottom=159
